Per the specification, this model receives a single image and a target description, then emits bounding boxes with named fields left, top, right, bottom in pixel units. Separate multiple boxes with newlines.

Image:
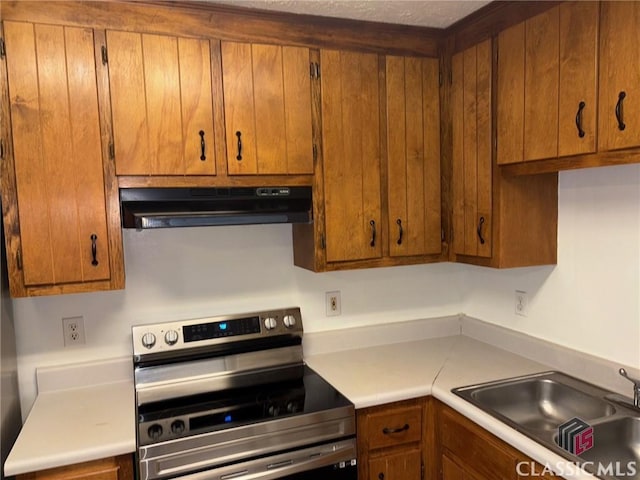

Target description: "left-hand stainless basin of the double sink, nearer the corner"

left=470, top=377, right=615, bottom=431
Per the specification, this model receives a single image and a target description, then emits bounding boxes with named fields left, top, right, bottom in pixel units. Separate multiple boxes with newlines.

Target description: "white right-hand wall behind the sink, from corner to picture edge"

left=462, top=165, right=640, bottom=367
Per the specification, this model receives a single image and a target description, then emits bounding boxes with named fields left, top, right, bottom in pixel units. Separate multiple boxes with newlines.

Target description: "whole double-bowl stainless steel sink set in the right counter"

left=452, top=372, right=640, bottom=480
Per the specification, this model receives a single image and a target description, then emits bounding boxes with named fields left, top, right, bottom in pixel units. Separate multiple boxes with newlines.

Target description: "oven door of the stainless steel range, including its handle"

left=152, top=438, right=358, bottom=480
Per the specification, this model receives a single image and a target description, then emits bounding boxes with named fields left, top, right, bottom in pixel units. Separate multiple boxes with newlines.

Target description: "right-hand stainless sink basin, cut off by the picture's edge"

left=572, top=417, right=640, bottom=480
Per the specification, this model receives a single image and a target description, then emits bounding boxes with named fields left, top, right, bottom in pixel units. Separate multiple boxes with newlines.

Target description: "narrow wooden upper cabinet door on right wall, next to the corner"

left=451, top=40, right=492, bottom=257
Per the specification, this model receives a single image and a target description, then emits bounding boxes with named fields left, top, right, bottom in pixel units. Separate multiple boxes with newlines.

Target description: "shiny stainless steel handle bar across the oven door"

left=160, top=439, right=356, bottom=480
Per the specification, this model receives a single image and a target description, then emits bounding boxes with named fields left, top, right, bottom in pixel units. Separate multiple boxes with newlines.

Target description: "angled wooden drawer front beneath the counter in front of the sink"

left=441, top=404, right=517, bottom=480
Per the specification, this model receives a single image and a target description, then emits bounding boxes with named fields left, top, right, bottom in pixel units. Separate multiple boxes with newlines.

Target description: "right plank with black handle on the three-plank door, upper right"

left=558, top=2, right=600, bottom=157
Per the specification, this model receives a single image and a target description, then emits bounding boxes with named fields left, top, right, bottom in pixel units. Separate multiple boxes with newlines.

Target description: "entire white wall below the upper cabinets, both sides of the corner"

left=14, top=165, right=640, bottom=415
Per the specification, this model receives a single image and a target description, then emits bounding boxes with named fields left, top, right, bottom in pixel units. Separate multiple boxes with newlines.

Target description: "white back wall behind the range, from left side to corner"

left=14, top=225, right=462, bottom=416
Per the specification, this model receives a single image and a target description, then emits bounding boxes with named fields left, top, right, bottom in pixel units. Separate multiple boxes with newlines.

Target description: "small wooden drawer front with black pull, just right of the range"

left=366, top=405, right=422, bottom=449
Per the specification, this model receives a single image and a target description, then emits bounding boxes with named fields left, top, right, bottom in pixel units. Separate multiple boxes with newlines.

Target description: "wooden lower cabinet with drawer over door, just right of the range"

left=356, top=398, right=429, bottom=480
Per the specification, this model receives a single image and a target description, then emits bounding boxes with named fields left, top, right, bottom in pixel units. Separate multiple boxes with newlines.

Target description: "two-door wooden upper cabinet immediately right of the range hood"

left=293, top=50, right=442, bottom=271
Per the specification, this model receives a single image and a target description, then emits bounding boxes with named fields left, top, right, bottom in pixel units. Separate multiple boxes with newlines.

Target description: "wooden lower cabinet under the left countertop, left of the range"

left=16, top=455, right=133, bottom=480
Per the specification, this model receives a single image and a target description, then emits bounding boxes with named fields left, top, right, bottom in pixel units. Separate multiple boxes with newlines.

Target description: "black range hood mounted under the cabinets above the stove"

left=120, top=187, right=312, bottom=230
